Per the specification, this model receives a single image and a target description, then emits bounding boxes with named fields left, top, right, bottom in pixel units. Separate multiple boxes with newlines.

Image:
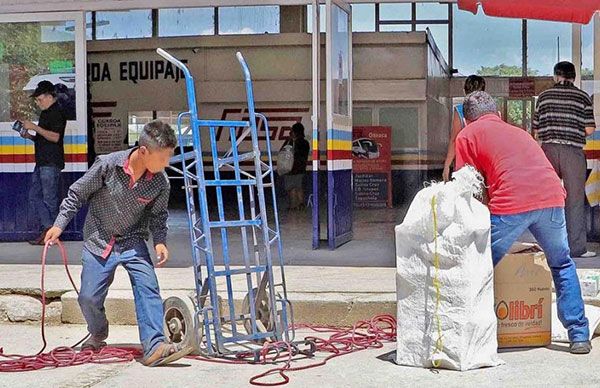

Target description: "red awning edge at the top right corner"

left=458, top=0, right=600, bottom=24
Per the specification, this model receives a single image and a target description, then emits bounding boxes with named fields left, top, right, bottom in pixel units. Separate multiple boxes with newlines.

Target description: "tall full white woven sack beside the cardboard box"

left=395, top=166, right=503, bottom=371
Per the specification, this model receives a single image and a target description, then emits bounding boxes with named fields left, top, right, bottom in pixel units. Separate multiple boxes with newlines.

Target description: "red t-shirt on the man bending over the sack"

left=456, top=114, right=566, bottom=215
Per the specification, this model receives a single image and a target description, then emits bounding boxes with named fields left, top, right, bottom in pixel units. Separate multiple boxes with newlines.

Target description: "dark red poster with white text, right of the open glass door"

left=352, top=127, right=392, bottom=208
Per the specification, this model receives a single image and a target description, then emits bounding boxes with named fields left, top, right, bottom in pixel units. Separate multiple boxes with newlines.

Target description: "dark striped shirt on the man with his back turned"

left=532, top=81, right=596, bottom=148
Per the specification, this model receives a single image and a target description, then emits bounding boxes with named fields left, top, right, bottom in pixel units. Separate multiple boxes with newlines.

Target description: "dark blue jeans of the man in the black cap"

left=29, top=166, right=60, bottom=230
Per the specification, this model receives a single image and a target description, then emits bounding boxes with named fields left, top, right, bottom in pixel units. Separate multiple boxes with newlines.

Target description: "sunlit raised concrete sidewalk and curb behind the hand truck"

left=0, top=265, right=600, bottom=325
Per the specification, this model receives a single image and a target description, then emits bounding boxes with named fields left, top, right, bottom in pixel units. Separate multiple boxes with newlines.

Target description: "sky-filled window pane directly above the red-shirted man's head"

left=454, top=6, right=522, bottom=76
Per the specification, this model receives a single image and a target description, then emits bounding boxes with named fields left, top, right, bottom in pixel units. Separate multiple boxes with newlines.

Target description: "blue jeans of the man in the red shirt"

left=492, top=207, right=590, bottom=342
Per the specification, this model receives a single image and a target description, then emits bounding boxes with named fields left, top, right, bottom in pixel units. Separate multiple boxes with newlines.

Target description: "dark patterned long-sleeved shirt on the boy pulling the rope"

left=54, top=150, right=170, bottom=258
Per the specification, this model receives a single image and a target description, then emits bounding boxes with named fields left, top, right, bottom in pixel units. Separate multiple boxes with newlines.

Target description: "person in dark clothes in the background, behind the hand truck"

left=282, top=123, right=310, bottom=210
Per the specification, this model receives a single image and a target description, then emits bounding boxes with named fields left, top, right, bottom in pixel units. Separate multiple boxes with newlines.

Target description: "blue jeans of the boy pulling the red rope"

left=79, top=243, right=166, bottom=357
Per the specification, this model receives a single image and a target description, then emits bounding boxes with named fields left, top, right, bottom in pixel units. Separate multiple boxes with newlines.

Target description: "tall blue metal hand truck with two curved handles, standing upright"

left=156, top=48, right=314, bottom=361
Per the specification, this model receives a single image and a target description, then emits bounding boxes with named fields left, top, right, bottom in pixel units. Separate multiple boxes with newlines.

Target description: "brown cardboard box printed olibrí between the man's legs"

left=494, top=243, right=552, bottom=348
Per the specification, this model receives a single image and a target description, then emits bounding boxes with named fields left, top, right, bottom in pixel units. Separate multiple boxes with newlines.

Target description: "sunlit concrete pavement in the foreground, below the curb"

left=0, top=323, right=600, bottom=388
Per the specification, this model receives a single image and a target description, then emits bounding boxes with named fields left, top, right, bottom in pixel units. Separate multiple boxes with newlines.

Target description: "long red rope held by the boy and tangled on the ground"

left=0, top=242, right=396, bottom=387
